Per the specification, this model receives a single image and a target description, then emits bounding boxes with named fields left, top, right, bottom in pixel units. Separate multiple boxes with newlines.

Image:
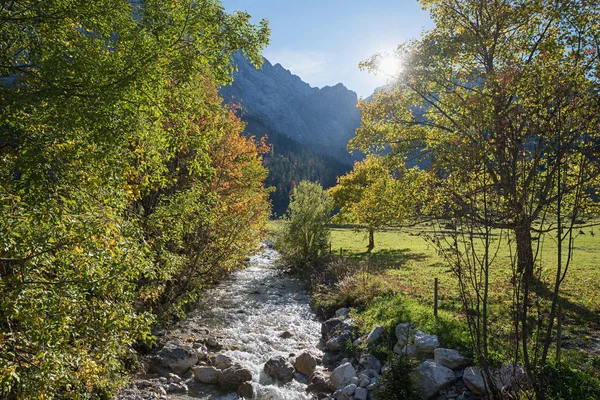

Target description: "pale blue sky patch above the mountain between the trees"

left=222, top=0, right=431, bottom=97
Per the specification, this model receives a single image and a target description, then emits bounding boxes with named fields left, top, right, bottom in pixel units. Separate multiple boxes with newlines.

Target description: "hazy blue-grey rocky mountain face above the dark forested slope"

left=221, top=55, right=360, bottom=161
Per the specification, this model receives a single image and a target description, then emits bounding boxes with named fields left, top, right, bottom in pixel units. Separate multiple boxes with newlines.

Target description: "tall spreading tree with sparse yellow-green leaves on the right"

left=353, top=0, right=600, bottom=399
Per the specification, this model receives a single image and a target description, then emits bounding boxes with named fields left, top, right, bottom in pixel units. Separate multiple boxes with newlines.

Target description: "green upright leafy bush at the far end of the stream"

left=278, top=181, right=333, bottom=270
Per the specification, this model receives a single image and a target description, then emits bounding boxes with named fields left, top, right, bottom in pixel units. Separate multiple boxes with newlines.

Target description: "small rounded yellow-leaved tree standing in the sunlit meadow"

left=329, top=155, right=412, bottom=253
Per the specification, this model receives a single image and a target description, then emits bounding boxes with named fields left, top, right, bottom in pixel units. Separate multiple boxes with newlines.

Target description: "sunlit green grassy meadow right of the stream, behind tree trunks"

left=270, top=222, right=600, bottom=375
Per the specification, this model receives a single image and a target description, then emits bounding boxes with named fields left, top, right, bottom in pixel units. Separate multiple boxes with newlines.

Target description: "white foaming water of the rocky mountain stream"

left=169, top=244, right=321, bottom=400
